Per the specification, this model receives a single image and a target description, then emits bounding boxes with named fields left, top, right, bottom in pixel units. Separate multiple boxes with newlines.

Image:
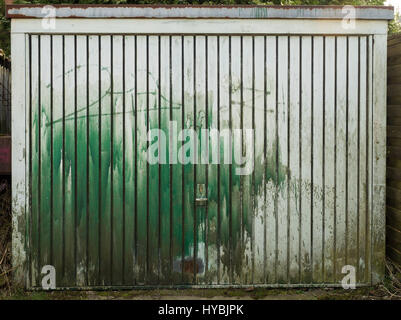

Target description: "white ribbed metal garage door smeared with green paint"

left=27, top=35, right=373, bottom=287
